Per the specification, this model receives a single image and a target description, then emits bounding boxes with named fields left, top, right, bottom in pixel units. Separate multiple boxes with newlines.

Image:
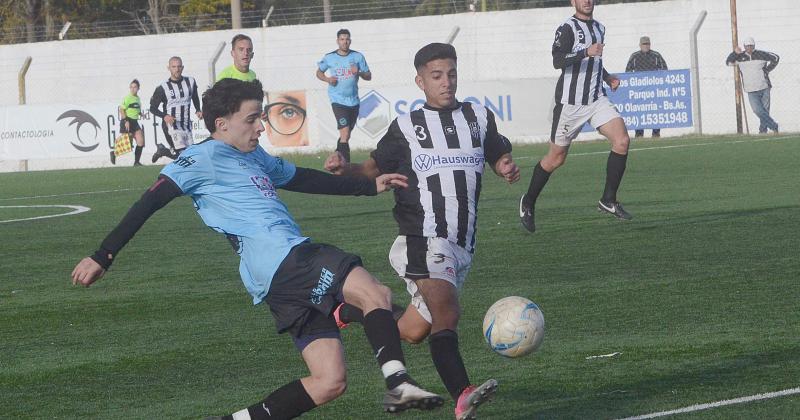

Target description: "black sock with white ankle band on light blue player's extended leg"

left=364, top=309, right=411, bottom=389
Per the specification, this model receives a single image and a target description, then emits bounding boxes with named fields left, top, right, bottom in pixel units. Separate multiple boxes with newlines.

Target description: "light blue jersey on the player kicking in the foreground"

left=161, top=139, right=308, bottom=304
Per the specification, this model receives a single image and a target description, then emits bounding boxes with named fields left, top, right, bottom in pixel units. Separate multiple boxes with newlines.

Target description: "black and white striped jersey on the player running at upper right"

left=552, top=16, right=608, bottom=105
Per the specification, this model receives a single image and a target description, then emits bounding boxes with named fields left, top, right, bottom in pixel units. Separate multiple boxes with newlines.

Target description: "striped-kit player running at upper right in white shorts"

left=519, top=0, right=632, bottom=232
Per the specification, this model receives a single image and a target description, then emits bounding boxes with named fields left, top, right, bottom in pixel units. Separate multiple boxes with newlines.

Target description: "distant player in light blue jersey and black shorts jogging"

left=317, top=29, right=372, bottom=162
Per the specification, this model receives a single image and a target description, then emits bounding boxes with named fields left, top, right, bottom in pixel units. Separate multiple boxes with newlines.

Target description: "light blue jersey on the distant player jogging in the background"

left=319, top=50, right=369, bottom=106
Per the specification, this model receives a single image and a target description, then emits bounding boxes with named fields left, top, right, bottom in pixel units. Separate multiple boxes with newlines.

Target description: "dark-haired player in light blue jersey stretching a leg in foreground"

left=72, top=79, right=443, bottom=420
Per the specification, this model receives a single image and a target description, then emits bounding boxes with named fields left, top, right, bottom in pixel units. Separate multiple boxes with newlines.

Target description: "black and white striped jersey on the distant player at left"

left=150, top=76, right=200, bottom=131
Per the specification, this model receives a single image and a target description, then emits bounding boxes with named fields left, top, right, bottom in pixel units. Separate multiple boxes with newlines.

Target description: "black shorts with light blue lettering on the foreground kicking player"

left=264, top=242, right=362, bottom=338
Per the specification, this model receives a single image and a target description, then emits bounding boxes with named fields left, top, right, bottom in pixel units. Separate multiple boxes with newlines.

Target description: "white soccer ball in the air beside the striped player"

left=483, top=296, right=544, bottom=357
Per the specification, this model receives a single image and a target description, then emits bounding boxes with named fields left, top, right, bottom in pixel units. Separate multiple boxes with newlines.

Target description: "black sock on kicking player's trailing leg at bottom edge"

left=223, top=379, right=317, bottom=420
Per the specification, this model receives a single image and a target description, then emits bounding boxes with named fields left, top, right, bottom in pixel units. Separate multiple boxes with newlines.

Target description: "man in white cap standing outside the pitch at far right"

left=725, top=37, right=780, bottom=134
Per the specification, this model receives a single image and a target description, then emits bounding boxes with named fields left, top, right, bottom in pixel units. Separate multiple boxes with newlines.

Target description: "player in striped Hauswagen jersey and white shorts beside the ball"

left=325, top=43, right=519, bottom=420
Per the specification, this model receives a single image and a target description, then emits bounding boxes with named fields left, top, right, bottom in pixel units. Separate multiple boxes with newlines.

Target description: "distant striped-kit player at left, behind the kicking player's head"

left=150, top=57, right=203, bottom=163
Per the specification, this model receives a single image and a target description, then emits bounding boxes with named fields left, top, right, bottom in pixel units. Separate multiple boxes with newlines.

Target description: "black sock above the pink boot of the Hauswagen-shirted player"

left=428, top=330, right=469, bottom=401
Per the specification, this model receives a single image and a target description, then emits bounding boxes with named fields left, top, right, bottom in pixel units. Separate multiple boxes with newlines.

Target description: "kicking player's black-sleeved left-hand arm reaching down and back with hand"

left=72, top=175, right=183, bottom=287
